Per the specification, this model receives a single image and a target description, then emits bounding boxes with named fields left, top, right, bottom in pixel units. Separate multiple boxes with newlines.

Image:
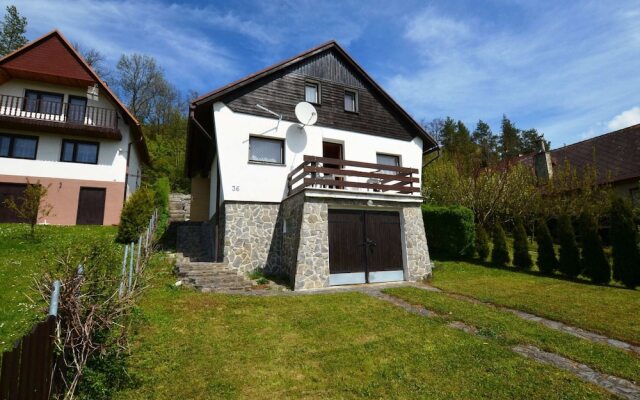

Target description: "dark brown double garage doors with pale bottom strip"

left=329, top=210, right=404, bottom=285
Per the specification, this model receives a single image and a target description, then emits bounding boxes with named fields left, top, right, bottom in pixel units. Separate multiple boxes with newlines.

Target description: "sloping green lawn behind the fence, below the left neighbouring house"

left=0, top=224, right=116, bottom=351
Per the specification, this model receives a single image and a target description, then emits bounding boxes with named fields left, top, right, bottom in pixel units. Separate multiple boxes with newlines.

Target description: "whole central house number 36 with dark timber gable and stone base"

left=186, top=41, right=436, bottom=289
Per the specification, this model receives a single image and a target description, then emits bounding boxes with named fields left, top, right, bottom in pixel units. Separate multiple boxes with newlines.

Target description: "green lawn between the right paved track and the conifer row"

left=431, top=261, right=640, bottom=344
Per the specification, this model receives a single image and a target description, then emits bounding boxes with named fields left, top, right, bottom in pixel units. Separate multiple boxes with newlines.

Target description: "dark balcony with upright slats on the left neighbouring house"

left=0, top=95, right=122, bottom=140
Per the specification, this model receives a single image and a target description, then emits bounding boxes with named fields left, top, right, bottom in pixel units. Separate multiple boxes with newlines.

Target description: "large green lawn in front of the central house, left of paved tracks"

left=116, top=262, right=610, bottom=400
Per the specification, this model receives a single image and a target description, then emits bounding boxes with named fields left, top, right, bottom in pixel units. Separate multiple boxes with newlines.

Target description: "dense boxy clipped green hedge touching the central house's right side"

left=422, top=205, right=476, bottom=259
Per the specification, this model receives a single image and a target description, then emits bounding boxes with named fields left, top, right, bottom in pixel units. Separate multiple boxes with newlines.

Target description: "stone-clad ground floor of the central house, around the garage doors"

left=221, top=192, right=431, bottom=290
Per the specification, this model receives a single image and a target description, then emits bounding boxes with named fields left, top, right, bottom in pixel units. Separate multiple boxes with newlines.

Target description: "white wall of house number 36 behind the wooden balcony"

left=211, top=102, right=422, bottom=202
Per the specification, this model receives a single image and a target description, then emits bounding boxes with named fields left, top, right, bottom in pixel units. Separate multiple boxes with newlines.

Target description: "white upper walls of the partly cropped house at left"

left=0, top=79, right=140, bottom=194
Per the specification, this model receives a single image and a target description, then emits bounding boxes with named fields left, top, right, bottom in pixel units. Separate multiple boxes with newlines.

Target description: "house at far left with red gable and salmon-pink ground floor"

left=0, top=31, right=149, bottom=225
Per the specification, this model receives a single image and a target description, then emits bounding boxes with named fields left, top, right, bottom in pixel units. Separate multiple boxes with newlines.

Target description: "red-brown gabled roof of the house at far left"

left=0, top=30, right=150, bottom=164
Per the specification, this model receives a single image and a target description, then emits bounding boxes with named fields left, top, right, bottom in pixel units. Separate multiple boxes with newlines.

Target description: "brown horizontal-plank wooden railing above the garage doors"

left=287, top=156, right=420, bottom=195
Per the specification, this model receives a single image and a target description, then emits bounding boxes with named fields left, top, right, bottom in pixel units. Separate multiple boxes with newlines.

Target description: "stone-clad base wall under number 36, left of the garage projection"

left=221, top=202, right=282, bottom=273
